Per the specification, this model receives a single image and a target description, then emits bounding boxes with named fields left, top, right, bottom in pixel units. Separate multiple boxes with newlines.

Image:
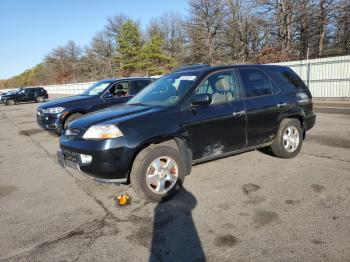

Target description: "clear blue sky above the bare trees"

left=0, top=0, right=188, bottom=79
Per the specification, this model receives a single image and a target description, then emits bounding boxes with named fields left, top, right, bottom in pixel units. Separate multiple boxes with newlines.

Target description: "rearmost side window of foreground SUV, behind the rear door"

left=270, top=67, right=306, bottom=91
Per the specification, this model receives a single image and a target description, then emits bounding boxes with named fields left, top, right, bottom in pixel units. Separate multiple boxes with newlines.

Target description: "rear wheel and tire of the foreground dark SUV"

left=271, top=118, right=303, bottom=158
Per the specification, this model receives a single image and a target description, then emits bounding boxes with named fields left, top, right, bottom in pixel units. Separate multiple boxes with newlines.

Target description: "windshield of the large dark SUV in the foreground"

left=127, top=72, right=198, bottom=106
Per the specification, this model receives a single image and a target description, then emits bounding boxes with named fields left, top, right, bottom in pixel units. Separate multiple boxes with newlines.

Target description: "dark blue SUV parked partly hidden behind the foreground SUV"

left=37, top=77, right=153, bottom=134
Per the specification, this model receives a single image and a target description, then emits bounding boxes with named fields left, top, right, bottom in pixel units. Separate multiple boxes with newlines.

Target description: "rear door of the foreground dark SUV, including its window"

left=238, top=68, right=288, bottom=147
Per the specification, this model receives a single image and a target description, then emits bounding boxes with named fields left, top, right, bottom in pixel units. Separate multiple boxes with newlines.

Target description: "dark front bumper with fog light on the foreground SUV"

left=57, top=136, right=135, bottom=183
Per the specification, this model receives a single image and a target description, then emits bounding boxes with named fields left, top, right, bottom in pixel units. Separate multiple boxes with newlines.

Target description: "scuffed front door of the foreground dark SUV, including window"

left=185, top=70, right=246, bottom=160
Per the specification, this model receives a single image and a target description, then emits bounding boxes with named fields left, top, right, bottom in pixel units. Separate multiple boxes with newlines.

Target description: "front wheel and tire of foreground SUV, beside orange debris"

left=130, top=145, right=185, bottom=202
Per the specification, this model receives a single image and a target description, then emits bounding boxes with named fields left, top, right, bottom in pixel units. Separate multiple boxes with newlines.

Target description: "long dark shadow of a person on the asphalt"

left=149, top=188, right=205, bottom=262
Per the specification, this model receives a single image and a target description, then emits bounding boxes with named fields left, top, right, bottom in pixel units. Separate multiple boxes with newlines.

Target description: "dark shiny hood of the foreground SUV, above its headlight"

left=69, top=104, right=164, bottom=129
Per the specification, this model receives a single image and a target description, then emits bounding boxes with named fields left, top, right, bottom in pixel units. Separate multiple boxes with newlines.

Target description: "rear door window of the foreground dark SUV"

left=239, top=69, right=272, bottom=97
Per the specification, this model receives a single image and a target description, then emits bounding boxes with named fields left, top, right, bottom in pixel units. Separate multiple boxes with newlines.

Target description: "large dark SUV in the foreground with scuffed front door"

left=58, top=65, right=316, bottom=201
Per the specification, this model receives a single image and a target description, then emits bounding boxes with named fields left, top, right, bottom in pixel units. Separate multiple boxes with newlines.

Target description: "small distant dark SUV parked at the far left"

left=1, top=87, right=49, bottom=105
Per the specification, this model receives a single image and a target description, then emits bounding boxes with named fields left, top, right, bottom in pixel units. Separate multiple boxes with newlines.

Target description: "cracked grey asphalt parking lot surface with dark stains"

left=0, top=99, right=350, bottom=261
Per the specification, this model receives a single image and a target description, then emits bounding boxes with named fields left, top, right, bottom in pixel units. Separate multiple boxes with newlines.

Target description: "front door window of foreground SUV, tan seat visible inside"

left=195, top=70, right=240, bottom=104
